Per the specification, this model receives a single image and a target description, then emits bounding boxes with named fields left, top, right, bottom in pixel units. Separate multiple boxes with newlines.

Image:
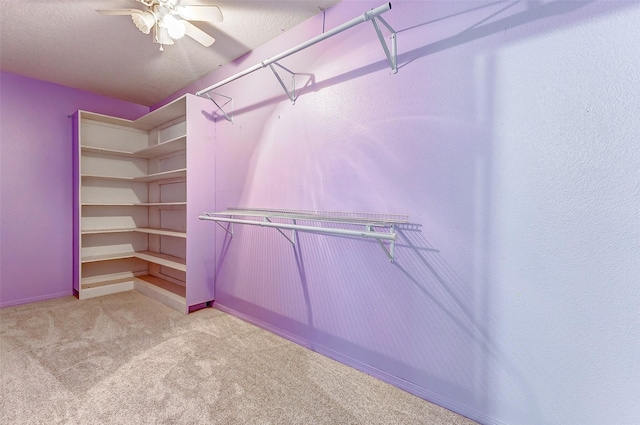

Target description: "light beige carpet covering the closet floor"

left=0, top=291, right=475, bottom=425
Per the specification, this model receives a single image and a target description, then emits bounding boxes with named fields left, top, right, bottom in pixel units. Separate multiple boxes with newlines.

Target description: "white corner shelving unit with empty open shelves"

left=74, top=95, right=214, bottom=313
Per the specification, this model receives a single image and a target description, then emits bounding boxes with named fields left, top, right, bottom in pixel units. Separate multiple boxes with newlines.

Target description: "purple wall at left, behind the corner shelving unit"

left=0, top=72, right=149, bottom=307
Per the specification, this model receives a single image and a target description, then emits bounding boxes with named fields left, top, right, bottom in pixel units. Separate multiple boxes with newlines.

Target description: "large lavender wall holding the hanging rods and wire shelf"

left=159, top=1, right=640, bottom=424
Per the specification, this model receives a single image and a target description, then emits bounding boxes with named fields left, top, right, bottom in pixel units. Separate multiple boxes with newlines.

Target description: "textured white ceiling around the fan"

left=0, top=0, right=339, bottom=106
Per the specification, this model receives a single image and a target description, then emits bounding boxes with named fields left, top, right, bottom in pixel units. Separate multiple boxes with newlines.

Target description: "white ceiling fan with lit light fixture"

left=96, top=0, right=222, bottom=51
